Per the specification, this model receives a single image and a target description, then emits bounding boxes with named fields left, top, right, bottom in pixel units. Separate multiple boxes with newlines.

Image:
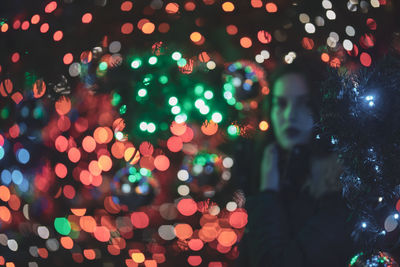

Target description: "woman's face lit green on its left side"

left=271, top=73, right=314, bottom=150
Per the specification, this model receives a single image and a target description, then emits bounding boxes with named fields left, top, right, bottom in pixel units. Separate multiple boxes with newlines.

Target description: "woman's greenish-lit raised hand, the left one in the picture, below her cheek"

left=260, top=143, right=279, bottom=191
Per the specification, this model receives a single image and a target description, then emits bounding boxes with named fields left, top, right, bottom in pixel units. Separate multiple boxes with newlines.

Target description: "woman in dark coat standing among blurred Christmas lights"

left=236, top=56, right=356, bottom=267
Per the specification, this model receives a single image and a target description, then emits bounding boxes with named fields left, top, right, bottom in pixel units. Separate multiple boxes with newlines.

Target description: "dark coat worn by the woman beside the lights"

left=236, top=139, right=357, bottom=267
